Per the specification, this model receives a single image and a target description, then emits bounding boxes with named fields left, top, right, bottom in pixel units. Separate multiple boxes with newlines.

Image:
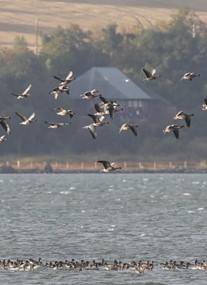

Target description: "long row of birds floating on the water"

left=0, top=255, right=207, bottom=274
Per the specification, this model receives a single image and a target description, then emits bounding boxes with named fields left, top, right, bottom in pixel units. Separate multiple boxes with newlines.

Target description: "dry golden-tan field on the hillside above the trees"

left=0, top=0, right=207, bottom=48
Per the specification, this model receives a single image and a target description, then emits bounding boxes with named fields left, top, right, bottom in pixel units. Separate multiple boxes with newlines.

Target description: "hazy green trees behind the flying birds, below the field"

left=0, top=8, right=207, bottom=159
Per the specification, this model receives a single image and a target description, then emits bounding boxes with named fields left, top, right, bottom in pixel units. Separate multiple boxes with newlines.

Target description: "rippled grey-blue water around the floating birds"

left=0, top=173, right=207, bottom=285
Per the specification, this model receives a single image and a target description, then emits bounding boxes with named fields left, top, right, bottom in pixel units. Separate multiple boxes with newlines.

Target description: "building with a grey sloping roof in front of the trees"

left=70, top=67, right=175, bottom=121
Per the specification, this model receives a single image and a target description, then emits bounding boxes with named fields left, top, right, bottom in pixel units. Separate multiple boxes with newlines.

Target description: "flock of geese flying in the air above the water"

left=0, top=68, right=204, bottom=172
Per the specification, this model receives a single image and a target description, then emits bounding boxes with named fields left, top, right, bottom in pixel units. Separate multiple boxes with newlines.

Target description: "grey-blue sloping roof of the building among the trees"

left=70, top=67, right=153, bottom=100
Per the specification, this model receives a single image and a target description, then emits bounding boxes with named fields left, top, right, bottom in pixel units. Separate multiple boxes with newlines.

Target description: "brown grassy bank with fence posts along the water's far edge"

left=0, top=160, right=207, bottom=173
